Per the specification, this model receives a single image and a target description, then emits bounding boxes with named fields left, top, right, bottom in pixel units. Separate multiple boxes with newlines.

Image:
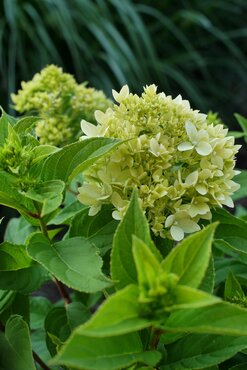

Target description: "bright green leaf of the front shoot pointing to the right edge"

left=162, top=302, right=247, bottom=336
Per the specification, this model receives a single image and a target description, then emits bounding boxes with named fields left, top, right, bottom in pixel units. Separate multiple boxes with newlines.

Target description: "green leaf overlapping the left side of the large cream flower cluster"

left=41, top=138, right=120, bottom=183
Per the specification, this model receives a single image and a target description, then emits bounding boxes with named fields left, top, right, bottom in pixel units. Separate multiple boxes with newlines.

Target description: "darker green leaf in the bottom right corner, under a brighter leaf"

left=161, top=334, right=247, bottom=370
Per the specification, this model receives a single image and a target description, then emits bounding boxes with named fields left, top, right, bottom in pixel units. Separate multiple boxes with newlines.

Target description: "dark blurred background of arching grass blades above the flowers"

left=0, top=0, right=247, bottom=125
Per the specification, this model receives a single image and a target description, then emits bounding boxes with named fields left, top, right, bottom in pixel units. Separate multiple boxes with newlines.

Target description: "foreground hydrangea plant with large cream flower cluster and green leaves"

left=0, top=68, right=247, bottom=370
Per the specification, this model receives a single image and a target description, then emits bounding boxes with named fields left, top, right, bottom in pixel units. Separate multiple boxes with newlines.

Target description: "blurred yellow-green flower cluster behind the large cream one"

left=11, top=65, right=112, bottom=146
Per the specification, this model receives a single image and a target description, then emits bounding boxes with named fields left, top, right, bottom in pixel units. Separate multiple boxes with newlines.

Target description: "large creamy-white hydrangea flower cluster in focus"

left=78, top=85, right=240, bottom=241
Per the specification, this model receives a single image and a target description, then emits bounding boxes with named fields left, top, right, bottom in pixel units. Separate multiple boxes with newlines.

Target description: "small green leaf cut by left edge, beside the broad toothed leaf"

left=0, top=242, right=32, bottom=271
